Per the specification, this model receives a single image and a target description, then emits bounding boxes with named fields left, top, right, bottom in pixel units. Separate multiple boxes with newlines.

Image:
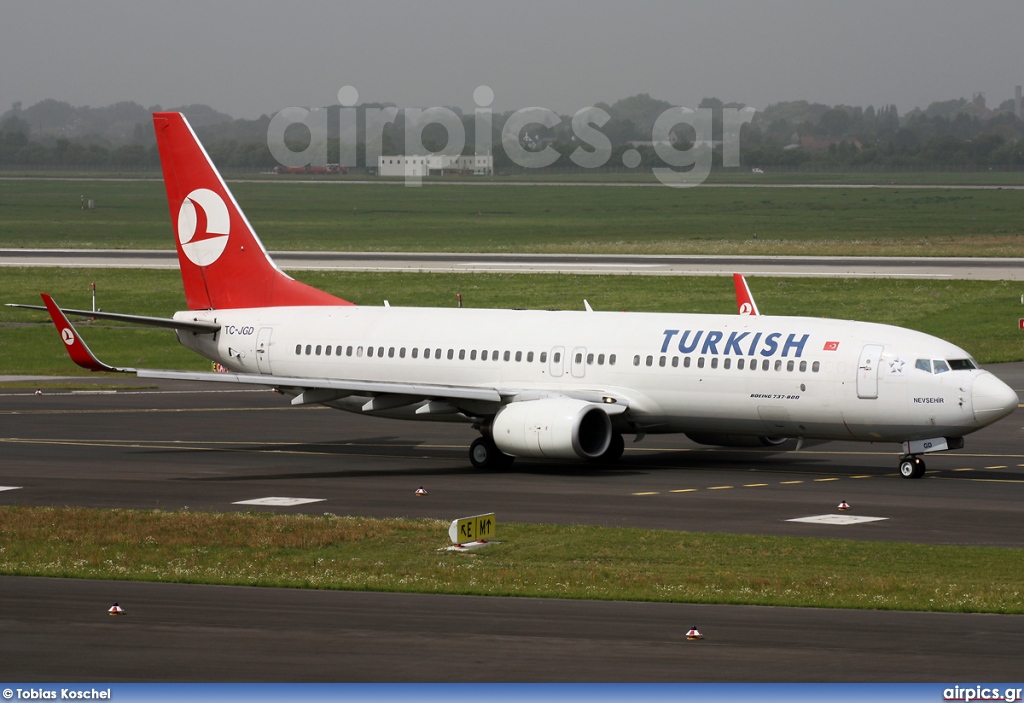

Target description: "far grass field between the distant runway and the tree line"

left=0, top=179, right=1024, bottom=257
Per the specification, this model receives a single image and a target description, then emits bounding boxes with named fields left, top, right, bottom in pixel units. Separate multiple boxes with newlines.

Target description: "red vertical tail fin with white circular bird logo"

left=153, top=113, right=351, bottom=310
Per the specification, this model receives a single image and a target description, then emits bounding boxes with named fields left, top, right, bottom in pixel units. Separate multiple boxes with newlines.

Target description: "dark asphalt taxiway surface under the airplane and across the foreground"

left=0, top=363, right=1024, bottom=682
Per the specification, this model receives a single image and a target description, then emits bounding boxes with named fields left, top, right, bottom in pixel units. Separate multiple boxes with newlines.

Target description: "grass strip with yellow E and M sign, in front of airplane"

left=0, top=507, right=1024, bottom=613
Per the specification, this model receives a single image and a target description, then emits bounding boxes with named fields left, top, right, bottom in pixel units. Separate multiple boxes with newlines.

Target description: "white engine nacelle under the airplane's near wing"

left=490, top=398, right=611, bottom=458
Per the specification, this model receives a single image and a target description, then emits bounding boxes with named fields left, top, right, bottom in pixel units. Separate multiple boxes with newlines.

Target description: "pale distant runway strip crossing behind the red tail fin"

left=0, top=249, right=1024, bottom=280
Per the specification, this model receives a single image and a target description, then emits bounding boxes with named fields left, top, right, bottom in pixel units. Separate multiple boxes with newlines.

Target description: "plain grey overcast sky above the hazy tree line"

left=0, top=0, right=1024, bottom=118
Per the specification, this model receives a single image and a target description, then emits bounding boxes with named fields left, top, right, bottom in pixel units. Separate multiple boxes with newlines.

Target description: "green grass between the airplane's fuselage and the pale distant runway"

left=6, top=267, right=1024, bottom=376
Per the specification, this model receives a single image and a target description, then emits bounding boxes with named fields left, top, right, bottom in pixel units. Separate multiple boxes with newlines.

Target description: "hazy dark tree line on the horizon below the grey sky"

left=0, top=94, right=1024, bottom=173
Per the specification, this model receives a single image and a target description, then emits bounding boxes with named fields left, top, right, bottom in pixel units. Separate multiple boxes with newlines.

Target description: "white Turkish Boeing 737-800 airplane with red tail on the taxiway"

left=12, top=113, right=1018, bottom=478
